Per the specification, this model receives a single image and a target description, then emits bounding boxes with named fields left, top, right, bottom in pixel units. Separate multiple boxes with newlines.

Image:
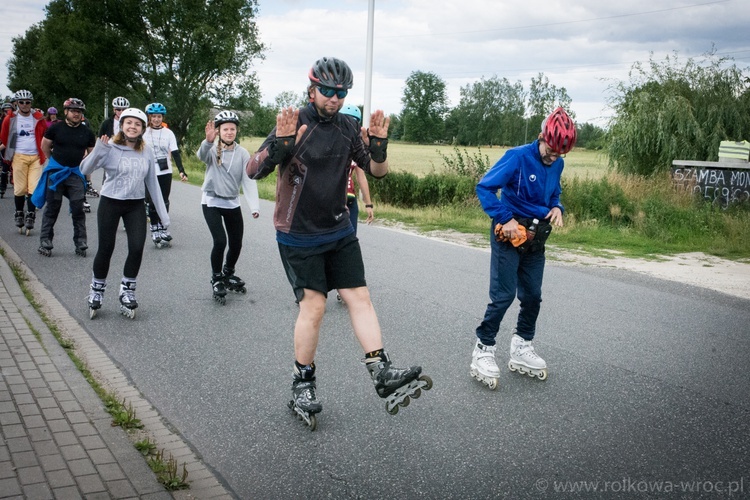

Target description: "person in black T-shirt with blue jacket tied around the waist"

left=31, top=97, right=96, bottom=257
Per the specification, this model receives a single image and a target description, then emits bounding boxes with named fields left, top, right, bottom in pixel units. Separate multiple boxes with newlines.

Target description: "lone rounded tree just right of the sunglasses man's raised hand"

left=401, top=71, right=448, bottom=144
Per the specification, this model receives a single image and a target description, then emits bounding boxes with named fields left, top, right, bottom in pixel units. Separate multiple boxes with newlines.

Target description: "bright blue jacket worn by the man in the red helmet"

left=476, top=140, right=565, bottom=224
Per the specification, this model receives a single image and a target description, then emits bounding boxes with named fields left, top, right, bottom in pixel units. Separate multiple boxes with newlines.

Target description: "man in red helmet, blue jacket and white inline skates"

left=471, top=108, right=576, bottom=389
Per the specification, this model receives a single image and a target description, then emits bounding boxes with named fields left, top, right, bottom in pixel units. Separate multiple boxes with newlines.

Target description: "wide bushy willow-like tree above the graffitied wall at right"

left=607, top=51, right=750, bottom=175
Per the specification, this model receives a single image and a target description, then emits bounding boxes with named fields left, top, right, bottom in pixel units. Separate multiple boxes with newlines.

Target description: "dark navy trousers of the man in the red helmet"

left=476, top=225, right=545, bottom=345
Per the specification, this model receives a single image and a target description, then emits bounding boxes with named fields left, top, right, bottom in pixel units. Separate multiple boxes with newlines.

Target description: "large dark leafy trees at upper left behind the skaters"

left=9, top=0, right=264, bottom=146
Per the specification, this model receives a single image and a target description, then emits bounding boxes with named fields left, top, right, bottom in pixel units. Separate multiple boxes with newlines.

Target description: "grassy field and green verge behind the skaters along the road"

left=186, top=137, right=750, bottom=259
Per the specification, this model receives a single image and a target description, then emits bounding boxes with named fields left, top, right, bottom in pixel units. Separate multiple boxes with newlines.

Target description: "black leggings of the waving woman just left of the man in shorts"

left=202, top=205, right=245, bottom=274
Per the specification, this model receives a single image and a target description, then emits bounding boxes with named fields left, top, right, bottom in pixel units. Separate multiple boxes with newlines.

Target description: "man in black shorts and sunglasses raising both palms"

left=247, top=57, right=426, bottom=429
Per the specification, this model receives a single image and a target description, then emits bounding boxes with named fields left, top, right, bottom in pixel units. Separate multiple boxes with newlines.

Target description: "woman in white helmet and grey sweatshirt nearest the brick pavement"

left=81, top=108, right=169, bottom=318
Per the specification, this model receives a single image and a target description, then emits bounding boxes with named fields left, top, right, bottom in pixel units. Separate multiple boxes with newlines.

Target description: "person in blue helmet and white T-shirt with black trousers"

left=143, top=102, right=188, bottom=247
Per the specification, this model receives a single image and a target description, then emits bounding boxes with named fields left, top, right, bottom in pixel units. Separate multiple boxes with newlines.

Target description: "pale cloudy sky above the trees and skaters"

left=0, top=0, right=750, bottom=125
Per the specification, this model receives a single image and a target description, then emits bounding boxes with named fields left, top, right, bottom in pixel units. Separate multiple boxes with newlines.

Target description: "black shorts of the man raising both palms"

left=279, top=234, right=367, bottom=301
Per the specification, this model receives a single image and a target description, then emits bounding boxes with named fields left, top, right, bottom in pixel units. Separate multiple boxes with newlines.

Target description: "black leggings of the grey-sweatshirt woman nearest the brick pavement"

left=94, top=196, right=146, bottom=280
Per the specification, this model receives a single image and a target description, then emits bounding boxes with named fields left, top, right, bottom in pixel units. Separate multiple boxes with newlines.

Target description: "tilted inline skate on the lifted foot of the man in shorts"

left=363, top=350, right=432, bottom=415
